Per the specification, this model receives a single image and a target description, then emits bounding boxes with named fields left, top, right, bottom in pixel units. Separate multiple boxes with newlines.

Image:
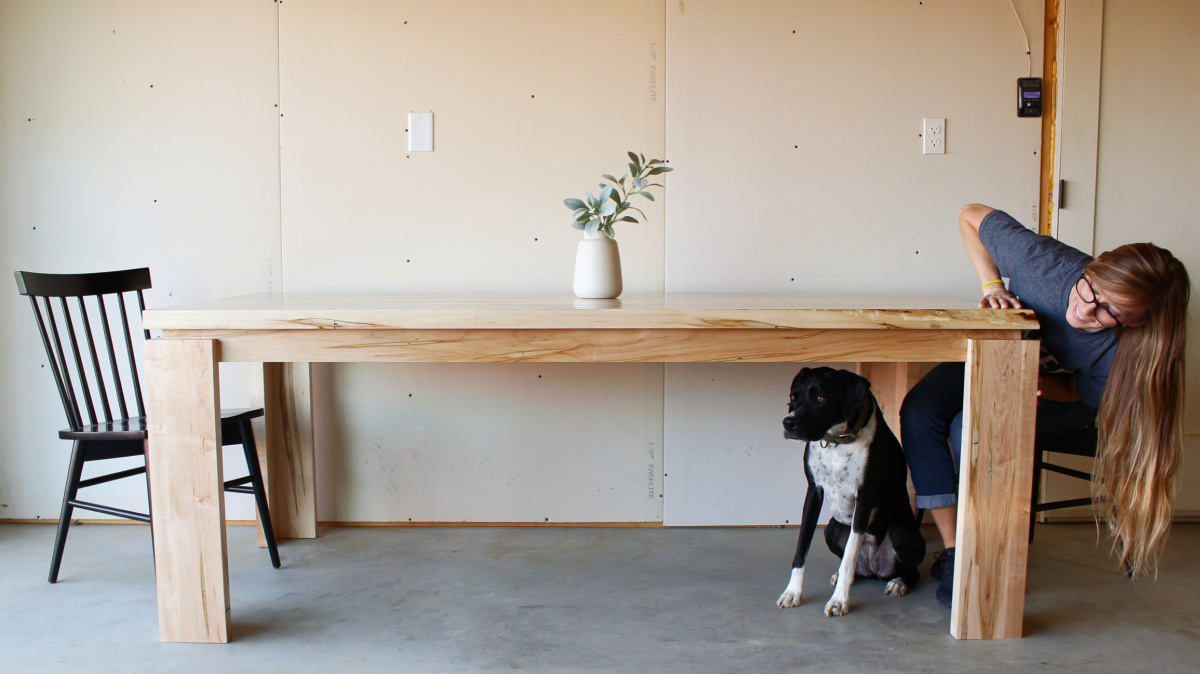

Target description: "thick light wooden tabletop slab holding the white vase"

left=143, top=293, right=1037, bottom=330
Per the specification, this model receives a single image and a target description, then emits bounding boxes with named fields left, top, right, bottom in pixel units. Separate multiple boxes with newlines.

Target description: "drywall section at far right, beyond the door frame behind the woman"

left=1096, top=0, right=1200, bottom=517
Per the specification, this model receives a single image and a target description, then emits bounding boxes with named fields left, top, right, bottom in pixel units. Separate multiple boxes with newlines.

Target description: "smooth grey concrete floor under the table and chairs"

left=0, top=524, right=1200, bottom=674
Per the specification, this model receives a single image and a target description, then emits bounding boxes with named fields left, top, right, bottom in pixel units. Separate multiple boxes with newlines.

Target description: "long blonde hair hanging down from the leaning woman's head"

left=1086, top=243, right=1192, bottom=576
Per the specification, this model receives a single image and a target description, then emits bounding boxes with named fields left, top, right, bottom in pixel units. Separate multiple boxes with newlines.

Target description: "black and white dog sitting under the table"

left=778, top=367, right=925, bottom=615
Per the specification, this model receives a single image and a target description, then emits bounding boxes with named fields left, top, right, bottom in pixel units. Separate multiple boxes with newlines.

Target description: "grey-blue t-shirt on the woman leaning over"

left=979, top=211, right=1117, bottom=408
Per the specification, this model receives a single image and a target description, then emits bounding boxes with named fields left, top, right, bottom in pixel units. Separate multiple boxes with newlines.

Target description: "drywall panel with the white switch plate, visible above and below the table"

left=280, top=0, right=666, bottom=522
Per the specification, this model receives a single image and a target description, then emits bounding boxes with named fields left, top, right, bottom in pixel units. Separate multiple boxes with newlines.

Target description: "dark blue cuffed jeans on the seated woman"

left=900, top=362, right=1096, bottom=510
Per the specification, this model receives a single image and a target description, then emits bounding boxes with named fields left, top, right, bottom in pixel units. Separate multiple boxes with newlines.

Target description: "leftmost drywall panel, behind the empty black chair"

left=0, top=0, right=278, bottom=519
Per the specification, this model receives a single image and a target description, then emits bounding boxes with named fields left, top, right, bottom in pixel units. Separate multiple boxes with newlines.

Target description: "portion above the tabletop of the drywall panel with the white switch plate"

left=280, top=0, right=665, bottom=293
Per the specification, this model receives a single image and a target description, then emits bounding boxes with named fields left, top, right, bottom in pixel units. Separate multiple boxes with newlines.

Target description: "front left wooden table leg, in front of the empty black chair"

left=145, top=339, right=229, bottom=643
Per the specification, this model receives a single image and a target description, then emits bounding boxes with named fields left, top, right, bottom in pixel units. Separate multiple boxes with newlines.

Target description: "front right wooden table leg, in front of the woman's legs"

left=950, top=339, right=1039, bottom=639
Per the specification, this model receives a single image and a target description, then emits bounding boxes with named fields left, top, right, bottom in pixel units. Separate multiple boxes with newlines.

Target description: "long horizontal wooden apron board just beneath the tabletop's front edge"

left=163, top=329, right=1020, bottom=362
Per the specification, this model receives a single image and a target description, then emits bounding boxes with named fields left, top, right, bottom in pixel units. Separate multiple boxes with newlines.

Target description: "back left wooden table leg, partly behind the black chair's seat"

left=259, top=362, right=317, bottom=537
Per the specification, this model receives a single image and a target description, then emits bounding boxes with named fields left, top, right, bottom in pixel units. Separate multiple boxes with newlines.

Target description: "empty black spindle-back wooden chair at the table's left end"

left=17, top=267, right=280, bottom=583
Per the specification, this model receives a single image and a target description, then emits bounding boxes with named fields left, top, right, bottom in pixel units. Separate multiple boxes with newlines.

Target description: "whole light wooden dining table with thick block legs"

left=143, top=293, right=1038, bottom=643
